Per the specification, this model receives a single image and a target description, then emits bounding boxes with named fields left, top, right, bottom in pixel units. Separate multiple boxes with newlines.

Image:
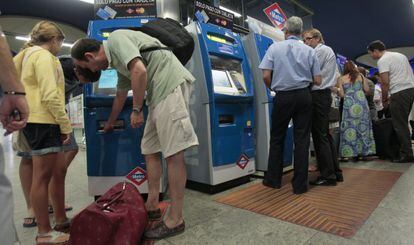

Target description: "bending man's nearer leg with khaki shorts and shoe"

left=144, top=82, right=198, bottom=239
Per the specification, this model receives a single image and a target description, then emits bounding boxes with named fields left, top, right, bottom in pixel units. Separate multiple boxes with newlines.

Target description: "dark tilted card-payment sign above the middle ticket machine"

left=194, top=1, right=234, bottom=30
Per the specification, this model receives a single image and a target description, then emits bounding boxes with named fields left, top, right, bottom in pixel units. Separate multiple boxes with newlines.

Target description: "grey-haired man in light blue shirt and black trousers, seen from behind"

left=259, top=16, right=321, bottom=194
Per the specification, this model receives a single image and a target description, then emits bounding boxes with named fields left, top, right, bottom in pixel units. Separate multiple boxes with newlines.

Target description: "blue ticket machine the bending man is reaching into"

left=84, top=19, right=166, bottom=196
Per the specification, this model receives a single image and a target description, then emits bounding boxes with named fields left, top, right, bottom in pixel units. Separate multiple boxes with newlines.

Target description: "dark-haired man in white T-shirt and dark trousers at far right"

left=367, top=40, right=414, bottom=162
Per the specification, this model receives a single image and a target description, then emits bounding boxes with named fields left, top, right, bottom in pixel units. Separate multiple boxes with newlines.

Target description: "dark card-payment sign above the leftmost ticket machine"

left=94, top=0, right=157, bottom=20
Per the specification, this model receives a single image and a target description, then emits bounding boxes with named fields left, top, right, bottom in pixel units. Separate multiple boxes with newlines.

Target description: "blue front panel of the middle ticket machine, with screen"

left=198, top=23, right=255, bottom=167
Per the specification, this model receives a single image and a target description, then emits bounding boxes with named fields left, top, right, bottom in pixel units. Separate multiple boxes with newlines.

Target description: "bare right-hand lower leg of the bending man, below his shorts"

left=165, top=151, right=187, bottom=228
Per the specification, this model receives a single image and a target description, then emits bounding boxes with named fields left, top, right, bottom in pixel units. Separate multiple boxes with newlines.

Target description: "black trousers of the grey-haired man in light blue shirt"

left=265, top=88, right=312, bottom=192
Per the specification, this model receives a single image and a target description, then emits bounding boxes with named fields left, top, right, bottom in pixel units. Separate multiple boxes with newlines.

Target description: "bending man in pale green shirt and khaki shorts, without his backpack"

left=71, top=27, right=198, bottom=239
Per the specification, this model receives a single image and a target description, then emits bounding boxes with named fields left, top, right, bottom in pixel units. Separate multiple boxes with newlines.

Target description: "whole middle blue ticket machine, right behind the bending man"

left=185, top=22, right=255, bottom=193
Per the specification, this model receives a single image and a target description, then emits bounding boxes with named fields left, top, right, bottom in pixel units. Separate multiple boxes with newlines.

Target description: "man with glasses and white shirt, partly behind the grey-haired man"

left=302, top=28, right=343, bottom=186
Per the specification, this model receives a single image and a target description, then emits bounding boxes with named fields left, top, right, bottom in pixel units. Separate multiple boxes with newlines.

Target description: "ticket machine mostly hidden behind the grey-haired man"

left=243, top=32, right=293, bottom=171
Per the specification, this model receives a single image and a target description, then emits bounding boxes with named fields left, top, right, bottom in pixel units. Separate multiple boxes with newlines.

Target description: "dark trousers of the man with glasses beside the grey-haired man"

left=312, top=89, right=341, bottom=179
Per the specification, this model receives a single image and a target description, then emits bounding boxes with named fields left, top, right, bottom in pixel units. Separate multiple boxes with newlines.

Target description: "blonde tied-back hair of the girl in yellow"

left=22, top=20, right=65, bottom=50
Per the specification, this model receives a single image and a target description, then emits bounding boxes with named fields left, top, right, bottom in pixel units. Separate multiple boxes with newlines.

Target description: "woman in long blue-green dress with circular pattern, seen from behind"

left=337, top=61, right=375, bottom=159
